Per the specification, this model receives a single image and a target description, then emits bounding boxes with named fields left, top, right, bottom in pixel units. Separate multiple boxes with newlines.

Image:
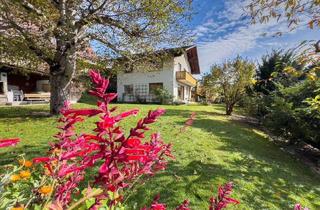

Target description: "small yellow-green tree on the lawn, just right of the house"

left=204, top=57, right=255, bottom=115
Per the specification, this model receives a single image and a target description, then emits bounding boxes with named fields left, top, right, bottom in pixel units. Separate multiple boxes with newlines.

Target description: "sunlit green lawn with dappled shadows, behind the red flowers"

left=0, top=104, right=320, bottom=209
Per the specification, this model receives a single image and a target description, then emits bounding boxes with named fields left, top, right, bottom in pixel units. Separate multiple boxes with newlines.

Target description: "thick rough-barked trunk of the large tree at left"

left=50, top=47, right=76, bottom=115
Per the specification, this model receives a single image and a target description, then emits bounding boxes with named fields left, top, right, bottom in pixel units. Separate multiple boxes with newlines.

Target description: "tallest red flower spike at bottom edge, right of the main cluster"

left=209, top=182, right=240, bottom=210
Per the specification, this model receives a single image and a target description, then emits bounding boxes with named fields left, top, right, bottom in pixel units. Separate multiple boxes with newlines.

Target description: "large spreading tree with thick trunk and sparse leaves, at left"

left=0, top=0, right=190, bottom=114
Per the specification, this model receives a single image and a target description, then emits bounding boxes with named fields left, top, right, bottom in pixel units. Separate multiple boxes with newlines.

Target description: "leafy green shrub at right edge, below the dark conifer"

left=262, top=80, right=320, bottom=148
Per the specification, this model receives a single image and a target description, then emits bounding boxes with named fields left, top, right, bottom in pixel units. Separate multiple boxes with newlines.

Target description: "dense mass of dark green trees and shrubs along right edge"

left=246, top=50, right=320, bottom=147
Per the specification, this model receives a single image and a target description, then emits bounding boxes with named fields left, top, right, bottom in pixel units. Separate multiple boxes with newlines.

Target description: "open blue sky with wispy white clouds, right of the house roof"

left=189, top=0, right=320, bottom=73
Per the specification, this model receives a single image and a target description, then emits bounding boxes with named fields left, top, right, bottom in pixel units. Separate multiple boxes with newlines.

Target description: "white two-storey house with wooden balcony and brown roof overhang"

left=117, top=46, right=200, bottom=103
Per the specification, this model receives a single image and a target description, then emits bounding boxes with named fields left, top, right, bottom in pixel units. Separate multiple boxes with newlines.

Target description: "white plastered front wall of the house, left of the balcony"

left=117, top=58, right=174, bottom=101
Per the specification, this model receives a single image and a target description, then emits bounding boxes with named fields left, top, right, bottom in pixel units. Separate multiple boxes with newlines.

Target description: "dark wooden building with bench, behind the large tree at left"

left=0, top=47, right=97, bottom=105
